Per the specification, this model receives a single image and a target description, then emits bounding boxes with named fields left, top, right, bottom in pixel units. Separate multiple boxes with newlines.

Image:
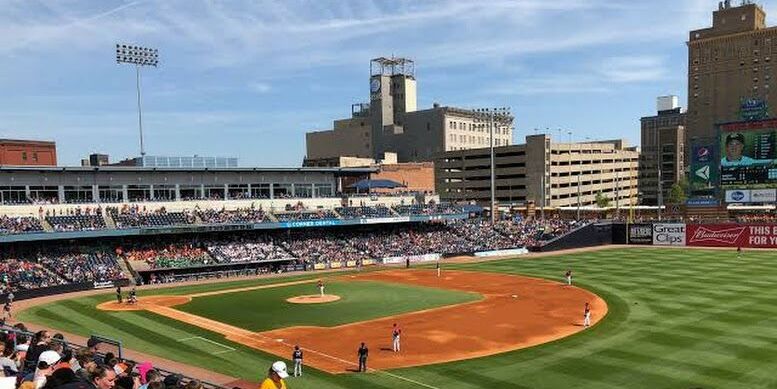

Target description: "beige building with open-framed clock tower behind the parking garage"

left=304, top=57, right=513, bottom=166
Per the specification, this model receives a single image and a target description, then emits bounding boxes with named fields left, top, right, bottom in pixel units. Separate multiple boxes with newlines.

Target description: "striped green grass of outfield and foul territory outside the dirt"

left=21, top=248, right=777, bottom=389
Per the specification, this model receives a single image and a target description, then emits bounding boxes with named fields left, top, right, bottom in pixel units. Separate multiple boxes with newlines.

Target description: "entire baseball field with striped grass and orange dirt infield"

left=18, top=247, right=777, bottom=389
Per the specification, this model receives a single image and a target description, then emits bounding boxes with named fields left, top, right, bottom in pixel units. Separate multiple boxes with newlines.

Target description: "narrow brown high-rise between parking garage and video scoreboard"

left=639, top=96, right=686, bottom=205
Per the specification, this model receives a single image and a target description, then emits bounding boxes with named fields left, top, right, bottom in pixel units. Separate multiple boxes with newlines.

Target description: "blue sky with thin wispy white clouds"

left=0, top=0, right=777, bottom=166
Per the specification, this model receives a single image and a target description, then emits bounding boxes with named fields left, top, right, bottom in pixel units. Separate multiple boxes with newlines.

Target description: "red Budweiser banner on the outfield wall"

left=685, top=224, right=777, bottom=248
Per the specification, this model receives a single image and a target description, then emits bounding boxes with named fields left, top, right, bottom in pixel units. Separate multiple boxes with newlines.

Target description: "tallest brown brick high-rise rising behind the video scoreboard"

left=686, top=0, right=777, bottom=153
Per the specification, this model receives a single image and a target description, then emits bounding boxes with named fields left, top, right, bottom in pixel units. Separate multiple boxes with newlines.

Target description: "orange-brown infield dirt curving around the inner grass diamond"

left=99, top=270, right=607, bottom=373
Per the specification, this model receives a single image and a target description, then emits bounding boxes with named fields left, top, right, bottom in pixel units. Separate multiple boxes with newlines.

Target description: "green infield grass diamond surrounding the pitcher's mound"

left=177, top=281, right=481, bottom=331
